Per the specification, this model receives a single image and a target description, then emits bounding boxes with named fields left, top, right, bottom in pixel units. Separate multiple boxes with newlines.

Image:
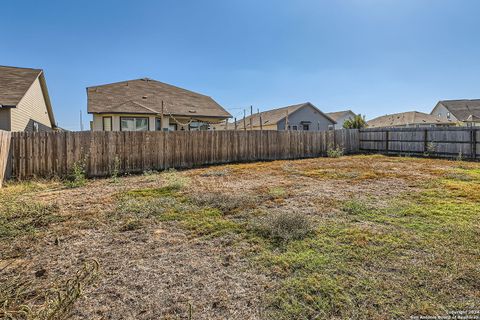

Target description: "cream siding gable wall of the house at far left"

left=10, top=78, right=52, bottom=131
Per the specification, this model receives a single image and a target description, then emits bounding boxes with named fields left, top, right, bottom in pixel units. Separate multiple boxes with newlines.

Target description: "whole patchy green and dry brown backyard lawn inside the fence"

left=0, top=155, right=480, bottom=319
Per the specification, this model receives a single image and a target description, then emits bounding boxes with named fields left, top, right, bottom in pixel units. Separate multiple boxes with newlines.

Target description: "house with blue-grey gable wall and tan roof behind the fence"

left=231, top=102, right=335, bottom=131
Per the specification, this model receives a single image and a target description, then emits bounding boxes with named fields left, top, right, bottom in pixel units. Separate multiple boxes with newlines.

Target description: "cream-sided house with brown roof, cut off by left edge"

left=0, top=66, right=56, bottom=132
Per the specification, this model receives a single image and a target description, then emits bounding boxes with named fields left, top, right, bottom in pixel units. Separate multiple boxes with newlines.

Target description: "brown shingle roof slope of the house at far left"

left=0, top=66, right=42, bottom=107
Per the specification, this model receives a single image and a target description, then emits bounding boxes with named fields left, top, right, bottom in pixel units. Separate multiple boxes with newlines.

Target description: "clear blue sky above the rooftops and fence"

left=0, top=0, right=480, bottom=130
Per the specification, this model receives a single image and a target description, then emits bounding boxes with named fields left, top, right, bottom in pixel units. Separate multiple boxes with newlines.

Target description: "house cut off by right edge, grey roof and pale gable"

left=431, top=99, right=480, bottom=126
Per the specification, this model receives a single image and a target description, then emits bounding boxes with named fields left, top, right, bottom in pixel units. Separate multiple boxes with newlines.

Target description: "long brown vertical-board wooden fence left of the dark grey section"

left=10, top=130, right=359, bottom=179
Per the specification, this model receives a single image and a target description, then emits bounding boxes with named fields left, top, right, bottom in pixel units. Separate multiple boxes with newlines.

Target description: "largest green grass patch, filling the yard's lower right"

left=259, top=179, right=480, bottom=319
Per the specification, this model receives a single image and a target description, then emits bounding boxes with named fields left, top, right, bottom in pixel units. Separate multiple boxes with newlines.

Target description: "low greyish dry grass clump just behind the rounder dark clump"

left=190, top=192, right=259, bottom=214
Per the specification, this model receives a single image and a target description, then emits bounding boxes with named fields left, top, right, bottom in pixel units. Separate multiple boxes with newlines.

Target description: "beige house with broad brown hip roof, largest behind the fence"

left=87, top=78, right=232, bottom=131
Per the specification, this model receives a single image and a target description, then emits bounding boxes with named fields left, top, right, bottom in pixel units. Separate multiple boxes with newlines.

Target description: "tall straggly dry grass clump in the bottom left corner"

left=0, top=260, right=99, bottom=320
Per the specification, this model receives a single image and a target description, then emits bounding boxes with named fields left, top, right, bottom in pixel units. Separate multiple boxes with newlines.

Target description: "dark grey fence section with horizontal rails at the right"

left=359, top=127, right=480, bottom=160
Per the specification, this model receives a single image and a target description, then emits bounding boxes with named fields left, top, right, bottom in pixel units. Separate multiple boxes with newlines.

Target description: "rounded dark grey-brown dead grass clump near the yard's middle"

left=256, top=212, right=313, bottom=243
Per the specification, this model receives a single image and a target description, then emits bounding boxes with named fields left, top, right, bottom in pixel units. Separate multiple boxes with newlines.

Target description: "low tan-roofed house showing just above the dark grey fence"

left=367, top=111, right=455, bottom=128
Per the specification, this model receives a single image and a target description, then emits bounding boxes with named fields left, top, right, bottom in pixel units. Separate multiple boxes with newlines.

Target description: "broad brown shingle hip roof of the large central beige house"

left=87, top=78, right=231, bottom=118
